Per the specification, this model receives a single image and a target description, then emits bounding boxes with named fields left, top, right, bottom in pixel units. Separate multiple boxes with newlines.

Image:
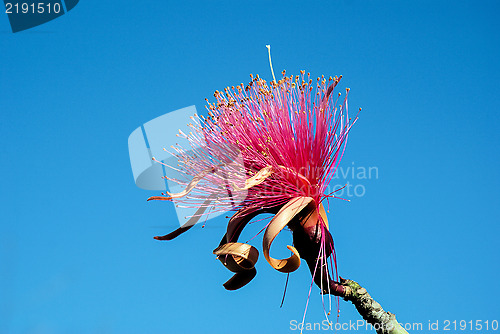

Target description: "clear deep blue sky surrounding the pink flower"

left=0, top=0, right=500, bottom=334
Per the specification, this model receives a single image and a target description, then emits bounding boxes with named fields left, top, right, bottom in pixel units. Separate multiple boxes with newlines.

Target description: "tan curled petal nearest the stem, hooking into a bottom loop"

left=262, top=197, right=314, bottom=273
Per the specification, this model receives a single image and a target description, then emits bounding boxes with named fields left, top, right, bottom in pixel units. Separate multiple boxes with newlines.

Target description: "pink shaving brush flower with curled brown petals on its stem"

left=148, top=71, right=408, bottom=333
